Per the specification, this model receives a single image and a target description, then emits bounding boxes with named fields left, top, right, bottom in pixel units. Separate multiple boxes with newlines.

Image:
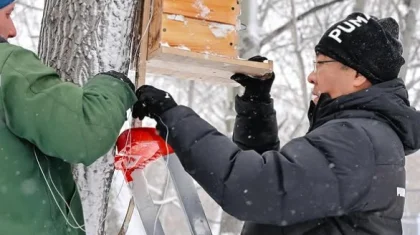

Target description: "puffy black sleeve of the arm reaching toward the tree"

left=158, top=106, right=374, bottom=226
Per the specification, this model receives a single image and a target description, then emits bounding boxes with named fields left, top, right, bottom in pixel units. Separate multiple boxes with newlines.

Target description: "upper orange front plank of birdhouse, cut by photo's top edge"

left=163, top=0, right=240, bottom=25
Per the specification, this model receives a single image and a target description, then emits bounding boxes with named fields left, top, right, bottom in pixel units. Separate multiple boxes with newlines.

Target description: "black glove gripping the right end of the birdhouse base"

left=230, top=56, right=275, bottom=102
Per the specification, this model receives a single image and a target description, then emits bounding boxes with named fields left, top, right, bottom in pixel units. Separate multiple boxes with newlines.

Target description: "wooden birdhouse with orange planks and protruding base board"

left=140, top=0, right=273, bottom=83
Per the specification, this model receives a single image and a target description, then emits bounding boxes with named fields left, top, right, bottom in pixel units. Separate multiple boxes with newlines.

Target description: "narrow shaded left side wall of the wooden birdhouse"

left=148, top=0, right=163, bottom=58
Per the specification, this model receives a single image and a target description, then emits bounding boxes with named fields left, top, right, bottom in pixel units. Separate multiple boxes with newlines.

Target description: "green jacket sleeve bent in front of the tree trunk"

left=0, top=47, right=136, bottom=165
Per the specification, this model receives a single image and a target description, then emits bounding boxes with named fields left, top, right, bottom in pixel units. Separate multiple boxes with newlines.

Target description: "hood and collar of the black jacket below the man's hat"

left=308, top=79, right=420, bottom=154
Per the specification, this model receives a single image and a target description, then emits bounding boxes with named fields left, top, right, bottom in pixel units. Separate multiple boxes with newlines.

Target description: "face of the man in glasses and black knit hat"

left=308, top=54, right=366, bottom=104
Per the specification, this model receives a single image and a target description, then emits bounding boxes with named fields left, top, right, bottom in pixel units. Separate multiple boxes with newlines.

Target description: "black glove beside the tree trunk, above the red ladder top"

left=132, top=85, right=178, bottom=120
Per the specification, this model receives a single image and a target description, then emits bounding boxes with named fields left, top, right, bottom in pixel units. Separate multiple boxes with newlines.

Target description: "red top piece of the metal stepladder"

left=114, top=127, right=174, bottom=182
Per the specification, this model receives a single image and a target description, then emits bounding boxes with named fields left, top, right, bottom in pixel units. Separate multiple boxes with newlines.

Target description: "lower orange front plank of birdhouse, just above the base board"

left=161, top=14, right=238, bottom=58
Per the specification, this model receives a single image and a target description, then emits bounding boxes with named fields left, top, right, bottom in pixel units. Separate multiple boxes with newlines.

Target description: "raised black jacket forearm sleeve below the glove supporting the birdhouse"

left=233, top=96, right=280, bottom=154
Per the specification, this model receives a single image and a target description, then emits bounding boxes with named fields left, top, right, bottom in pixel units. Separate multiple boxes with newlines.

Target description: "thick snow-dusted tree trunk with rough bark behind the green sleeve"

left=38, top=0, right=136, bottom=235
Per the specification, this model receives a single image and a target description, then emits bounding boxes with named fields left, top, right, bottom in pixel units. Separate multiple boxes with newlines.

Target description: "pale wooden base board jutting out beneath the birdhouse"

left=147, top=47, right=273, bottom=85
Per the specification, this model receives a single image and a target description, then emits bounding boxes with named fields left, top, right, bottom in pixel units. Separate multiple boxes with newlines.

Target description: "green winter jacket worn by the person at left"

left=0, top=43, right=136, bottom=235
